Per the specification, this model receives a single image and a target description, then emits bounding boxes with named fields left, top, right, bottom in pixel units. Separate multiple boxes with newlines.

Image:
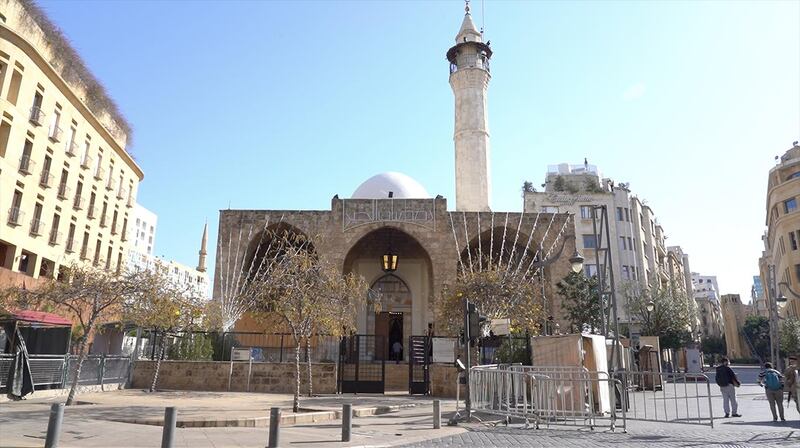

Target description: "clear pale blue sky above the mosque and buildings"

left=40, top=0, right=800, bottom=301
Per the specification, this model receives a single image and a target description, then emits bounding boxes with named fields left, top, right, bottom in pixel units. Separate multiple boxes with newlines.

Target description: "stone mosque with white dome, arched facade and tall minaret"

left=214, top=8, right=575, bottom=350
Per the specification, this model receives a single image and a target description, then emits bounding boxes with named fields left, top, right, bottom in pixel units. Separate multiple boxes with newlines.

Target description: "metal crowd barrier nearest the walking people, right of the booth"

left=614, top=371, right=714, bottom=428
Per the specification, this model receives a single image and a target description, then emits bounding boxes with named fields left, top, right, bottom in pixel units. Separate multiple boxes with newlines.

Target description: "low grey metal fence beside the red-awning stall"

left=0, top=354, right=130, bottom=389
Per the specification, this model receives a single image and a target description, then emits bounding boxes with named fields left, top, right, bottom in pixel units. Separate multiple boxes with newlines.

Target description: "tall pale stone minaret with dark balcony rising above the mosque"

left=447, top=0, right=492, bottom=212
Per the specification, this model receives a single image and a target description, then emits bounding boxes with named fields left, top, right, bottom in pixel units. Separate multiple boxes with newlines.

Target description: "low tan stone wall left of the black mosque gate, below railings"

left=132, top=361, right=336, bottom=394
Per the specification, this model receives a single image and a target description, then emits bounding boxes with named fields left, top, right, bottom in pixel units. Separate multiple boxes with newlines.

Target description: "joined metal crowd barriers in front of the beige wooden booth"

left=470, top=365, right=627, bottom=431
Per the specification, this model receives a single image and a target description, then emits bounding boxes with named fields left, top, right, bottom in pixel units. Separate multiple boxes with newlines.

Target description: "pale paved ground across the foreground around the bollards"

left=0, top=367, right=800, bottom=447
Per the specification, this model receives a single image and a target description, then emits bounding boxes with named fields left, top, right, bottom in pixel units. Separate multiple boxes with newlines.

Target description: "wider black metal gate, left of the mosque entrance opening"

left=339, top=334, right=386, bottom=394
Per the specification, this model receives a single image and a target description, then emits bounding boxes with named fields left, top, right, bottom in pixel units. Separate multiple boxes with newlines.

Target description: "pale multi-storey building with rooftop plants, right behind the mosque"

left=524, top=162, right=691, bottom=326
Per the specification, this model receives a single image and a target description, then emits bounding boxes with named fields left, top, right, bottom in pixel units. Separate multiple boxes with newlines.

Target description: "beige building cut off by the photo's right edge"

left=759, top=142, right=800, bottom=318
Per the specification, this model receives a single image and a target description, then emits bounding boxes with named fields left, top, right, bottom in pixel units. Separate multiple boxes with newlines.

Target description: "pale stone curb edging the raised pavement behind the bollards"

left=106, top=404, right=417, bottom=428
